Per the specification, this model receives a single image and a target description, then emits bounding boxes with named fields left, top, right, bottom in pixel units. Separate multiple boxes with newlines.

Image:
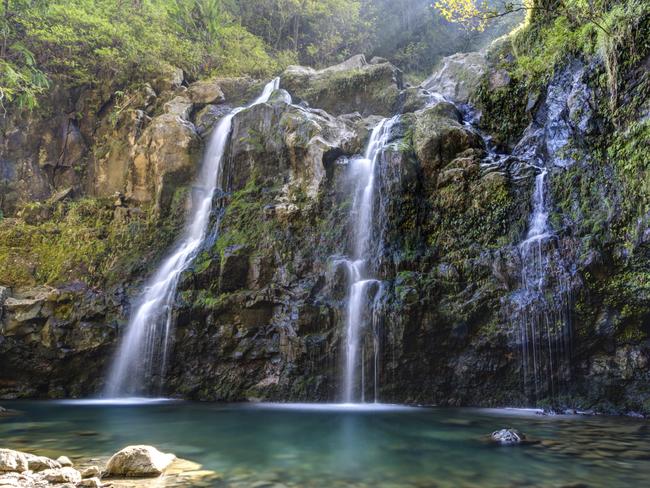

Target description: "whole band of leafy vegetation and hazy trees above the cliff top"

left=0, top=0, right=512, bottom=110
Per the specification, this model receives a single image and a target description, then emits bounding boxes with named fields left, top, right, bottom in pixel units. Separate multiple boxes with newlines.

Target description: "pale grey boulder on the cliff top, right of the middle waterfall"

left=421, top=52, right=487, bottom=103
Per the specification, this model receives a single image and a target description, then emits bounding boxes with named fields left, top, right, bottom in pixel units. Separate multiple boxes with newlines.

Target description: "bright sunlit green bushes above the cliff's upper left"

left=0, top=0, right=288, bottom=108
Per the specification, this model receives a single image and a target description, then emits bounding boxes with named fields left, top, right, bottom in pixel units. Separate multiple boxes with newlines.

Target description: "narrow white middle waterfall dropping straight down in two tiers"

left=342, top=116, right=398, bottom=403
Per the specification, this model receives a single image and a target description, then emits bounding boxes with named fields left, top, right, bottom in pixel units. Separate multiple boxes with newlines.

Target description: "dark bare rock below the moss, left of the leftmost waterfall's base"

left=0, top=283, right=122, bottom=398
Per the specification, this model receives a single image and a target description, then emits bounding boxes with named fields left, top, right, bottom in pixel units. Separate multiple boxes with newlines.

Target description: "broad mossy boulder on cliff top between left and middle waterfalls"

left=280, top=55, right=403, bottom=116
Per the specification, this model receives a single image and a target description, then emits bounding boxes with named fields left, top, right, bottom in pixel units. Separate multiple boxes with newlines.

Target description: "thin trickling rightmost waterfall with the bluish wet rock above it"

left=510, top=60, right=593, bottom=402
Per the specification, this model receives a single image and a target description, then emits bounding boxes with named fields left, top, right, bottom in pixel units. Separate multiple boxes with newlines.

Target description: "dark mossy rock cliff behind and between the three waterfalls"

left=0, top=10, right=650, bottom=413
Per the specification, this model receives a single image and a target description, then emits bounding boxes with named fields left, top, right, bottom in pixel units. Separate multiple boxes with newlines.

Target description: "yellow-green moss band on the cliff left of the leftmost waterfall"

left=0, top=193, right=186, bottom=287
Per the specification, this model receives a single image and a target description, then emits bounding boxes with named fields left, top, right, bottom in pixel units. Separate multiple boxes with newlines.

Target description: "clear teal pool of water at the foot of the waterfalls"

left=0, top=400, right=650, bottom=488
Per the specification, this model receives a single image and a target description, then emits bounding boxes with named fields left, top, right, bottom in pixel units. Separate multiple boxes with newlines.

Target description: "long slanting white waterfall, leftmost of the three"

left=105, top=78, right=280, bottom=397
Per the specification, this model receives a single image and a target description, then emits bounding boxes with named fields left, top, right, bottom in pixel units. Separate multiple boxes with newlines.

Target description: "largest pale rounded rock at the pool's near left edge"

left=106, top=446, right=176, bottom=477
